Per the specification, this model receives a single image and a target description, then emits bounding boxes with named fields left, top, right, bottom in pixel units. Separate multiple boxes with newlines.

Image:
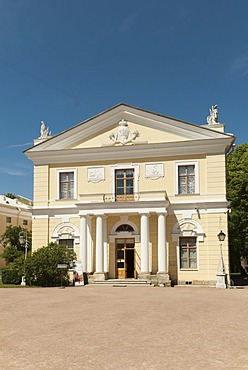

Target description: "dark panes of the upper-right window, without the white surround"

left=178, top=165, right=195, bottom=194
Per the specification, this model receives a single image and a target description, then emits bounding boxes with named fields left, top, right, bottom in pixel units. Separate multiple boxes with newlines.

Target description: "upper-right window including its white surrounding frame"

left=176, top=162, right=199, bottom=194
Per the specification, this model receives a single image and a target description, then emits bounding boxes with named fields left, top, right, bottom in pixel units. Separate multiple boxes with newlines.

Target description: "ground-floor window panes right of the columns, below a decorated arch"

left=179, top=237, right=197, bottom=269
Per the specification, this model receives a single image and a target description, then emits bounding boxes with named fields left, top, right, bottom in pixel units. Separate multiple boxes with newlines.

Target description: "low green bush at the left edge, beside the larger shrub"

left=2, top=256, right=24, bottom=285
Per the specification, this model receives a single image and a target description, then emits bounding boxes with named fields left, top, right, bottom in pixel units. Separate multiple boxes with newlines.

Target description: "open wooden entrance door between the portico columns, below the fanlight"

left=116, top=239, right=135, bottom=279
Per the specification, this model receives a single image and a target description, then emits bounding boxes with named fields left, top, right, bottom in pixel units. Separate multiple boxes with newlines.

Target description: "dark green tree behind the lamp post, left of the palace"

left=0, top=226, right=32, bottom=263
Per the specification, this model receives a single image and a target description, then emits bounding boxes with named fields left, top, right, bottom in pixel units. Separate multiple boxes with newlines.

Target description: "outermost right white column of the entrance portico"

left=158, top=213, right=167, bottom=273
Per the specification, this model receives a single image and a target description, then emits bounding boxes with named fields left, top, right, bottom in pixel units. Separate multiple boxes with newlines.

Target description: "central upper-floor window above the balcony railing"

left=115, top=168, right=134, bottom=200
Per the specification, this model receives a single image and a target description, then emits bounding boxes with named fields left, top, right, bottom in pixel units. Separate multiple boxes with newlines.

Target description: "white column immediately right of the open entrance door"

left=140, top=214, right=149, bottom=274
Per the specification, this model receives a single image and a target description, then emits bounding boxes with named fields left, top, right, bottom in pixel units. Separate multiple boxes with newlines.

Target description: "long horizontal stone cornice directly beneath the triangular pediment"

left=25, top=136, right=235, bottom=165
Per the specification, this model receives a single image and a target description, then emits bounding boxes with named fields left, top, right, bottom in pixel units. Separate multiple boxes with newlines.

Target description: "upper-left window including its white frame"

left=57, top=169, right=77, bottom=199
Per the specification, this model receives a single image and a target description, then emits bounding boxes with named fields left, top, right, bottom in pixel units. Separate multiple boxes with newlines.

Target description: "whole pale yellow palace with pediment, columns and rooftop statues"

left=25, top=103, right=235, bottom=286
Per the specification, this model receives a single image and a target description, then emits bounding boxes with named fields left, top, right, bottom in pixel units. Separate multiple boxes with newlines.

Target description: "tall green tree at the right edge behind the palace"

left=227, top=144, right=248, bottom=272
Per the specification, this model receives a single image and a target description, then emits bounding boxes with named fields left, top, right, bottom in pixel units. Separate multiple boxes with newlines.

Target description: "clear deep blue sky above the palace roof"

left=0, top=0, right=248, bottom=199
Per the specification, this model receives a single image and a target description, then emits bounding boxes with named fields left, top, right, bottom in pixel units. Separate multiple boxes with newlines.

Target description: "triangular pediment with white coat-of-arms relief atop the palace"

left=26, top=104, right=230, bottom=154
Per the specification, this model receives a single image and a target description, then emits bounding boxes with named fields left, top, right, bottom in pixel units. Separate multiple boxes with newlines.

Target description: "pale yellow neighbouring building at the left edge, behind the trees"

left=0, top=195, right=32, bottom=269
